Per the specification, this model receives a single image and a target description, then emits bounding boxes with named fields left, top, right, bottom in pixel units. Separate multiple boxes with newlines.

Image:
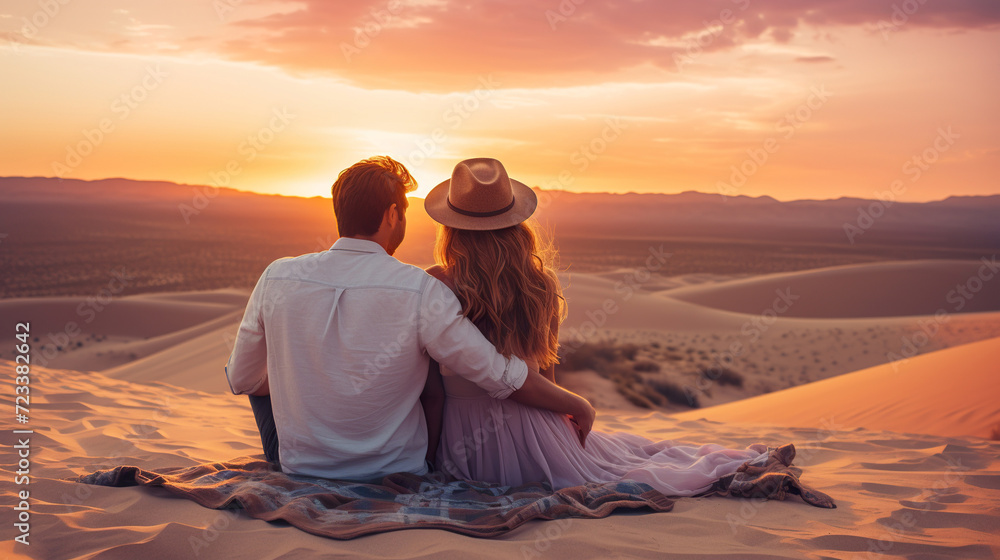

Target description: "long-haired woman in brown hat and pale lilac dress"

left=425, top=158, right=820, bottom=496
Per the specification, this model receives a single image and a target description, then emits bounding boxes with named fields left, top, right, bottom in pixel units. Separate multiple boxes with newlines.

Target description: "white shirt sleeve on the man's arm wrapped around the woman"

left=417, top=277, right=528, bottom=399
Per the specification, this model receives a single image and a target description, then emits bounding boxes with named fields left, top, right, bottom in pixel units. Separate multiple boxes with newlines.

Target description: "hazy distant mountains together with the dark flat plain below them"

left=0, top=177, right=1000, bottom=297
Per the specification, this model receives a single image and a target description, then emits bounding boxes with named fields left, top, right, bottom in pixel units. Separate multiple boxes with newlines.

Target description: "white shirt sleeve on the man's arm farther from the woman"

left=226, top=267, right=270, bottom=395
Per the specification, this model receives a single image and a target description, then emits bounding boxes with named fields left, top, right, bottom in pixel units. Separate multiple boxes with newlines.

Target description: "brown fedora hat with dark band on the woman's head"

left=424, top=158, right=538, bottom=230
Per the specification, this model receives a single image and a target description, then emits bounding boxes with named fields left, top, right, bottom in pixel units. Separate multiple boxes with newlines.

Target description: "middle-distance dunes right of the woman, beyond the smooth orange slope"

left=560, top=261, right=1000, bottom=410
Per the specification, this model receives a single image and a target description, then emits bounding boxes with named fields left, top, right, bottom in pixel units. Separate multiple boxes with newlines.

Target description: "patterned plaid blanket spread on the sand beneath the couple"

left=78, top=457, right=674, bottom=539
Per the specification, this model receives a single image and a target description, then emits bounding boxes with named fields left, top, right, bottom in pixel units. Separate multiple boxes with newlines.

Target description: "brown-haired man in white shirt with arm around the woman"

left=226, top=157, right=595, bottom=480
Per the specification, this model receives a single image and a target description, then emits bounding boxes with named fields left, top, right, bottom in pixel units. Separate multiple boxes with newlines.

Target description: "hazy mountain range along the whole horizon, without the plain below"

left=7, top=177, right=1000, bottom=247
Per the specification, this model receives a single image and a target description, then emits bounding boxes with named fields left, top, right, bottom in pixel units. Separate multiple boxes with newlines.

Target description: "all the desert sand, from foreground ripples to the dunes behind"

left=0, top=261, right=1000, bottom=559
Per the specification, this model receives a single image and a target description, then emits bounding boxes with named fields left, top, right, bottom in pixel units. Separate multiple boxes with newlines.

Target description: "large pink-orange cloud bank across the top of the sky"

left=209, top=0, right=1000, bottom=90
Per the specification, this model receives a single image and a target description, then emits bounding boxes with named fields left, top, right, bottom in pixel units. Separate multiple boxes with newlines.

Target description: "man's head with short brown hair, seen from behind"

left=331, top=156, right=417, bottom=237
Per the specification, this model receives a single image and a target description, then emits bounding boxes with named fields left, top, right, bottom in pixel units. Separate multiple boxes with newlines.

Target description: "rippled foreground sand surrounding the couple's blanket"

left=0, top=358, right=1000, bottom=560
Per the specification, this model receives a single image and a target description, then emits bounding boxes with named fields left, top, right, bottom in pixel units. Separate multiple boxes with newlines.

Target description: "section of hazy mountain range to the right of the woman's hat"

left=539, top=187, right=1000, bottom=246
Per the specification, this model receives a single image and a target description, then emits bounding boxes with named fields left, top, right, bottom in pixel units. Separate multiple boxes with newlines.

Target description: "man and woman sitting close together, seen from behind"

left=226, top=157, right=828, bottom=496
